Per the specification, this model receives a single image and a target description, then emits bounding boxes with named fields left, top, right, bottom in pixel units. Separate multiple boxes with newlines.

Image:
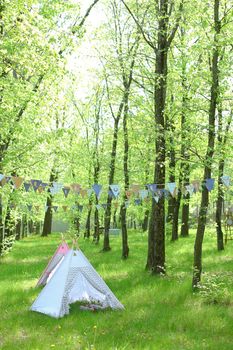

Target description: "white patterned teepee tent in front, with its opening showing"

left=30, top=249, right=124, bottom=318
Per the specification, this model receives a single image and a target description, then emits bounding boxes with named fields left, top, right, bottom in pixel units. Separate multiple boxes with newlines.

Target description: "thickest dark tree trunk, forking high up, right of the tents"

left=147, top=0, right=168, bottom=274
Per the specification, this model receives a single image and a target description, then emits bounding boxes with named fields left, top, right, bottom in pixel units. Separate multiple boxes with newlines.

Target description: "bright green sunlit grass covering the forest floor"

left=0, top=231, right=233, bottom=350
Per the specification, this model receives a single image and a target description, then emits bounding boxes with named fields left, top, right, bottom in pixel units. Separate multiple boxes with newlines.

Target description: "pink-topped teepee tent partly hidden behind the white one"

left=36, top=241, right=69, bottom=286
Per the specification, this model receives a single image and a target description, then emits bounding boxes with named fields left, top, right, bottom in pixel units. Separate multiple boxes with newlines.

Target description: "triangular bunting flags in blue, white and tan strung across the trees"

left=0, top=174, right=231, bottom=212
